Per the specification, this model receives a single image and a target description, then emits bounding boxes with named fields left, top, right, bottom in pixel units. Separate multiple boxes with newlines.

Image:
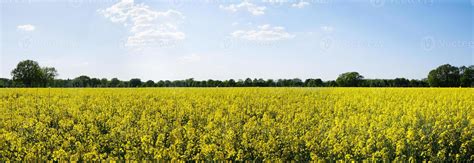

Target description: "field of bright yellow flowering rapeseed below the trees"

left=0, top=88, right=474, bottom=162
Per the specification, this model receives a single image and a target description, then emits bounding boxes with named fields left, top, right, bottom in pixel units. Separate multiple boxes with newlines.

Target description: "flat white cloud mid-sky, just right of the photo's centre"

left=231, top=24, right=295, bottom=41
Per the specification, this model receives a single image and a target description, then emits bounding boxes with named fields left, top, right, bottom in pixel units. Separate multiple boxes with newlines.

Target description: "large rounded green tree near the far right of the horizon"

left=428, top=64, right=460, bottom=87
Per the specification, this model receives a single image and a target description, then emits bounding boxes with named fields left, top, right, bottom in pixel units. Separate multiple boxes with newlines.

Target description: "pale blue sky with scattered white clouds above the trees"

left=0, top=0, right=474, bottom=80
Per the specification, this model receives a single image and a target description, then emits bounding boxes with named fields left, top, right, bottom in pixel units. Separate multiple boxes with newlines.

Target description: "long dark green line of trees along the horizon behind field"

left=0, top=60, right=474, bottom=88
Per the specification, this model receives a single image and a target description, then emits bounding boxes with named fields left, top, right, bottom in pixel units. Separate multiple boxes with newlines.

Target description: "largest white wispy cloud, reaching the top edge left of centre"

left=98, top=0, right=186, bottom=48
